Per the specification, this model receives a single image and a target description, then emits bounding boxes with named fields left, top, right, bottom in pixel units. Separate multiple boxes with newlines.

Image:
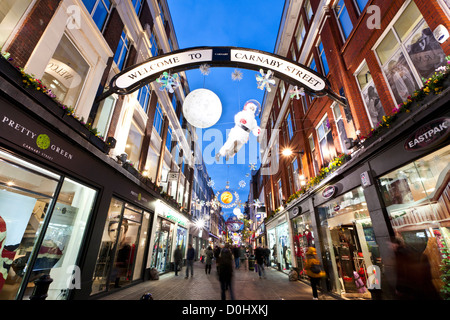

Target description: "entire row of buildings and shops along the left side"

left=0, top=0, right=218, bottom=299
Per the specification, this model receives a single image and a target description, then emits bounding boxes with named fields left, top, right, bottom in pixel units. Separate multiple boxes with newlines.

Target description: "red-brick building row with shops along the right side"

left=261, top=0, right=450, bottom=299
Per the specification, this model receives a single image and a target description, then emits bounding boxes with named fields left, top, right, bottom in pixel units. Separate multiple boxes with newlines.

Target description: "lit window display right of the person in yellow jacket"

left=318, top=187, right=381, bottom=298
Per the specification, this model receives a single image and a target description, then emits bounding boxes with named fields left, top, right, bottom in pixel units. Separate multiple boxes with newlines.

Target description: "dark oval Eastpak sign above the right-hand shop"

left=404, top=118, right=450, bottom=151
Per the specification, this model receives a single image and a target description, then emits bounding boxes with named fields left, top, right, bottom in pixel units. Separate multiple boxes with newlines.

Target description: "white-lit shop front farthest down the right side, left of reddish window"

left=267, top=211, right=293, bottom=273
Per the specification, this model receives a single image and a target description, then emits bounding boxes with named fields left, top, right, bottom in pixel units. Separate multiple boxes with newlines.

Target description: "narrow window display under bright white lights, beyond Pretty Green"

left=152, top=217, right=175, bottom=272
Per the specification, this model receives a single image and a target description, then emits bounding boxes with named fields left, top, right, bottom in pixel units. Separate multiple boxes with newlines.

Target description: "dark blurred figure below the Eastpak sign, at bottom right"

left=392, top=238, right=440, bottom=300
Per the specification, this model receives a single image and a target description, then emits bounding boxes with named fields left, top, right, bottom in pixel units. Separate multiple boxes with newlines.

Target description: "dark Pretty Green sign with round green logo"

left=0, top=101, right=83, bottom=166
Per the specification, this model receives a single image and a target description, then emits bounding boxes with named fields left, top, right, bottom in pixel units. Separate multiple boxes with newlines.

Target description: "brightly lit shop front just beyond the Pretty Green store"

left=149, top=200, right=189, bottom=273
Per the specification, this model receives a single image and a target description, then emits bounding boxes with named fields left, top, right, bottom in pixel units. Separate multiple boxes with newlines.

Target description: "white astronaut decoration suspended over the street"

left=216, top=99, right=261, bottom=161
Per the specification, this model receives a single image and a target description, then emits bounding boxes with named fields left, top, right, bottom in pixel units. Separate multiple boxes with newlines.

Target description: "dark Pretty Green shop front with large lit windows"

left=0, top=63, right=160, bottom=300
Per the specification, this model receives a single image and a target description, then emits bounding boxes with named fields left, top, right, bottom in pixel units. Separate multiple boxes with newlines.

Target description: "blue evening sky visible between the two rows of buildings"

left=168, top=0, right=284, bottom=212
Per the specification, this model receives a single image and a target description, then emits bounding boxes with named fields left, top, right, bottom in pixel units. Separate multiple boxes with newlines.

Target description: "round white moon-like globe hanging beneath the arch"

left=183, top=89, right=222, bottom=128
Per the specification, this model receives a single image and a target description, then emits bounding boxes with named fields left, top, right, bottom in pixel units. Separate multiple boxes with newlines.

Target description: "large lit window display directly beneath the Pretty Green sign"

left=0, top=151, right=97, bottom=300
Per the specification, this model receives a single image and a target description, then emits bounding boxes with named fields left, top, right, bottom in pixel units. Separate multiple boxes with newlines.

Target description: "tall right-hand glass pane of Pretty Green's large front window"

left=26, top=178, right=97, bottom=300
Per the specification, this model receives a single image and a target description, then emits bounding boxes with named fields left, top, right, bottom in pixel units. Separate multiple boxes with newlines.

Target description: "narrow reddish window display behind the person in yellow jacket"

left=292, top=213, right=315, bottom=278
